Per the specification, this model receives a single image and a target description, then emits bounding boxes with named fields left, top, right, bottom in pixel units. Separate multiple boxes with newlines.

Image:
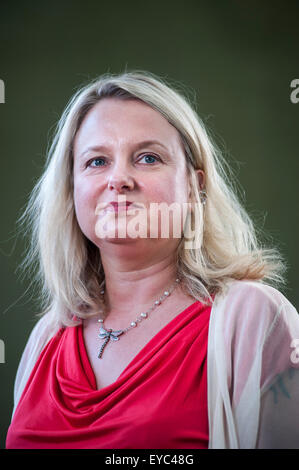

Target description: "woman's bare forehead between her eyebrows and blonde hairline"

left=74, top=98, right=183, bottom=154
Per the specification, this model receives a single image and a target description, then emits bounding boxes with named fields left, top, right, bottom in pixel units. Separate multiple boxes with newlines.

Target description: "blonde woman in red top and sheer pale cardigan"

left=7, top=71, right=299, bottom=449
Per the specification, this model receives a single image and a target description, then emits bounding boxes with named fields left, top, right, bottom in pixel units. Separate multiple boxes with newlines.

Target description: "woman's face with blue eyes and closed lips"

left=74, top=98, right=197, bottom=248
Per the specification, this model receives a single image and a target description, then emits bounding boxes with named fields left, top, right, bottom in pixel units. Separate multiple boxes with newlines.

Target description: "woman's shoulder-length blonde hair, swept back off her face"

left=18, top=71, right=284, bottom=329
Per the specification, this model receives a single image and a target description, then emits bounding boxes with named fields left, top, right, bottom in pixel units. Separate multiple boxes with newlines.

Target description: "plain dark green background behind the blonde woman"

left=0, top=0, right=299, bottom=447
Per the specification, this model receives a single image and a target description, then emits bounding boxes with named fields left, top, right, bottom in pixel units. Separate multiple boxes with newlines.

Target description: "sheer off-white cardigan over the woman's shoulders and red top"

left=14, top=281, right=299, bottom=449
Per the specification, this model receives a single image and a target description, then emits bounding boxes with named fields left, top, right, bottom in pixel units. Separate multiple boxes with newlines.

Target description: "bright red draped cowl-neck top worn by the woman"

left=6, top=301, right=211, bottom=449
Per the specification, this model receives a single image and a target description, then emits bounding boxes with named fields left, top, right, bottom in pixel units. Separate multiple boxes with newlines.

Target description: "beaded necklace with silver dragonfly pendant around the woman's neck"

left=98, top=279, right=180, bottom=359
